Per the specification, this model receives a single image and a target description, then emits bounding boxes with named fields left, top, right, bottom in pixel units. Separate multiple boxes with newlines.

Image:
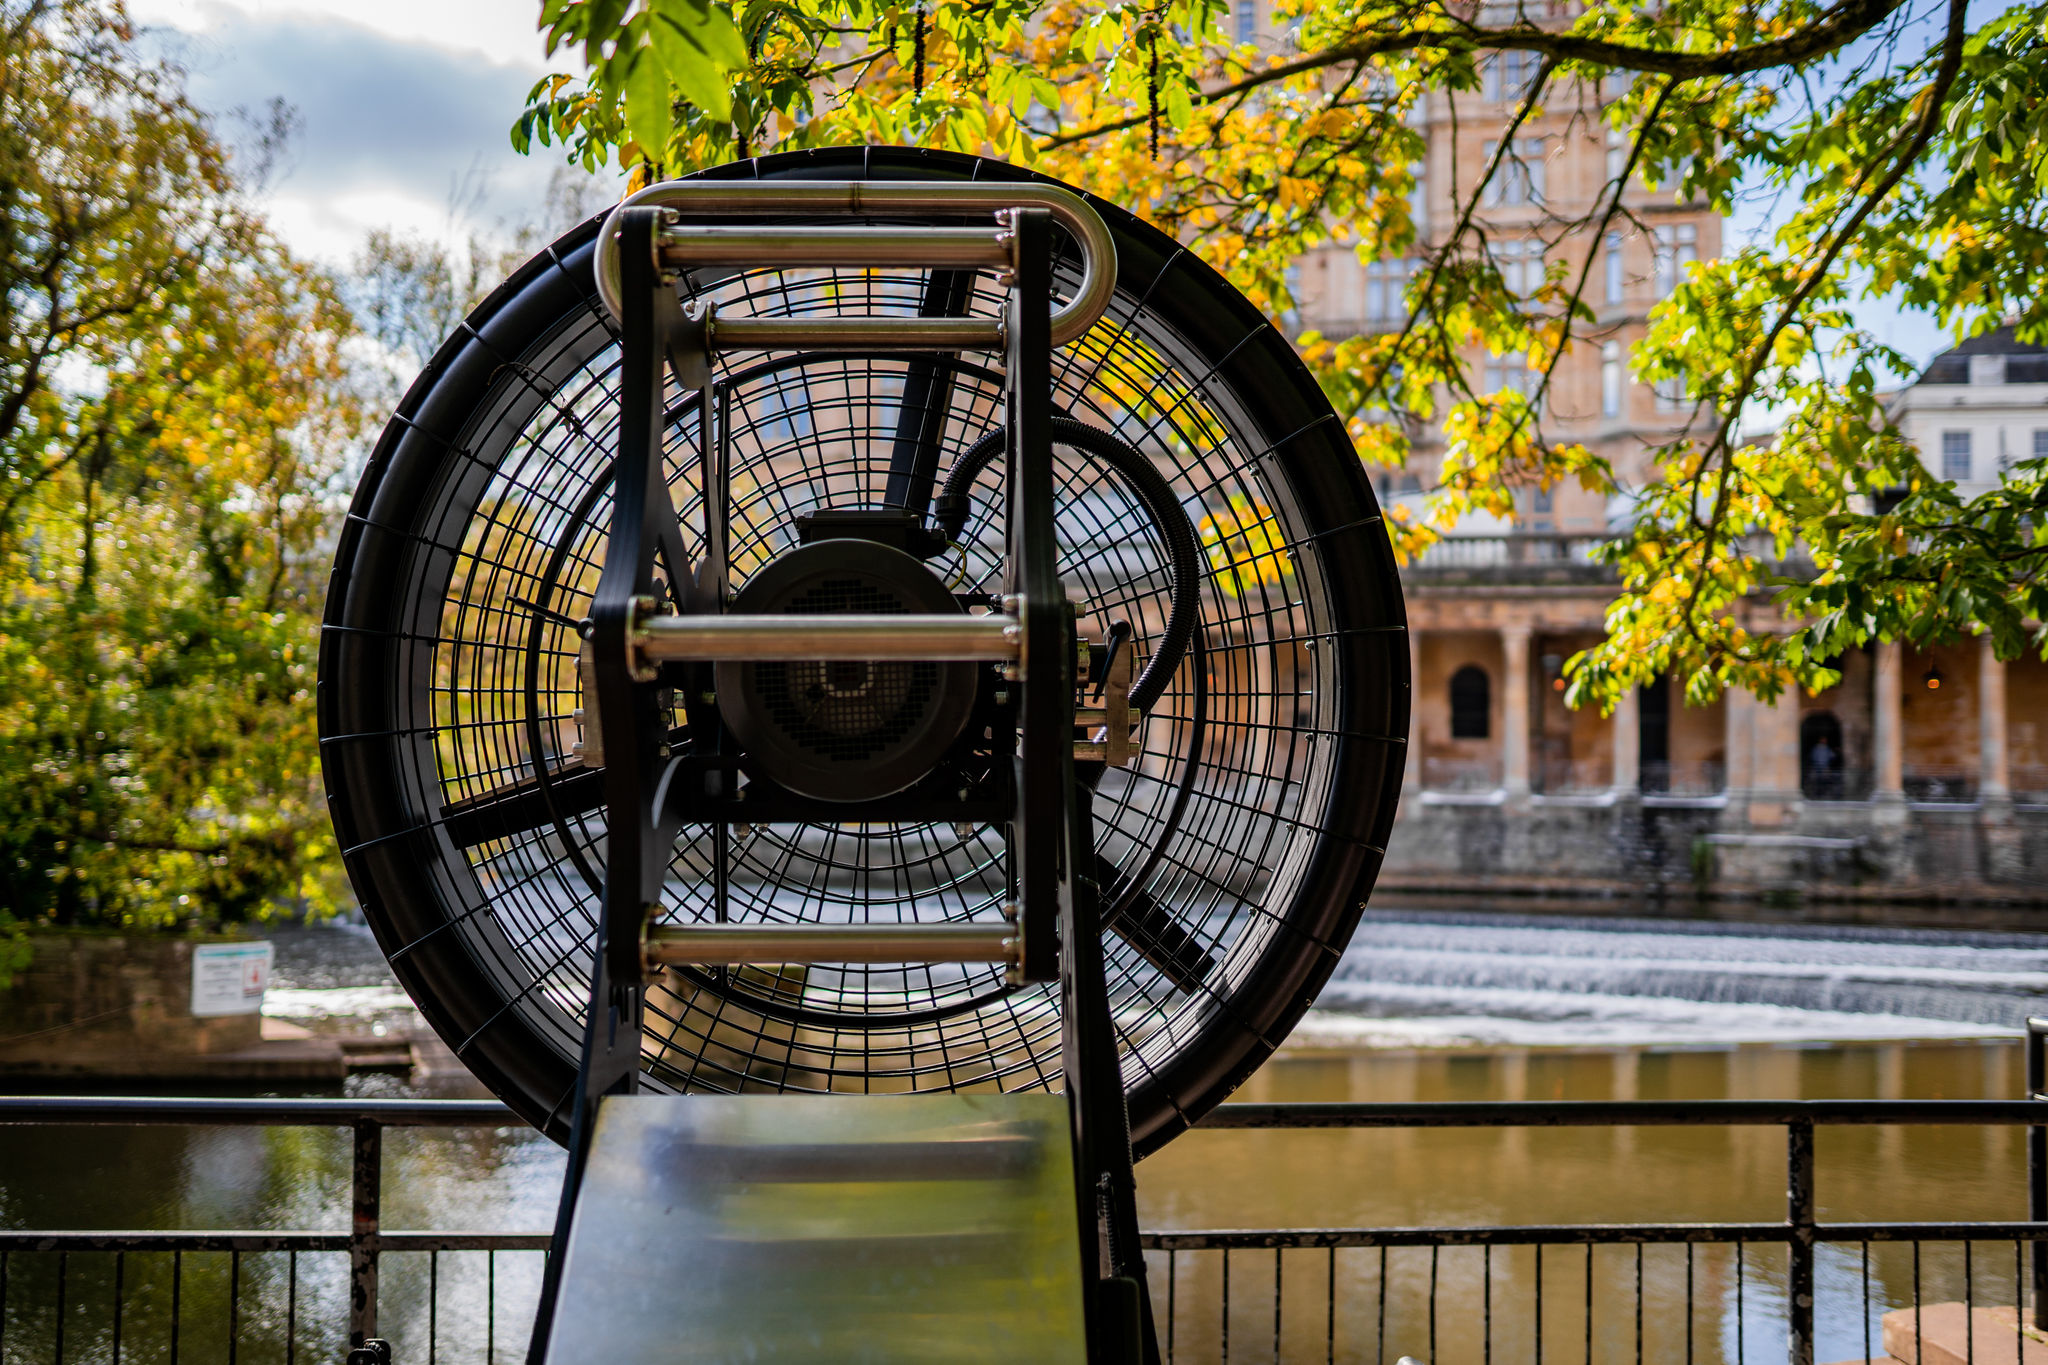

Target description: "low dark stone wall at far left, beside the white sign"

left=0, top=933, right=262, bottom=1076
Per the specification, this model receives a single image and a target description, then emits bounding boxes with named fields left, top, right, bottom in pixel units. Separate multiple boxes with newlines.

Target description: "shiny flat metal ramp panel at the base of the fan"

left=547, top=1095, right=1087, bottom=1365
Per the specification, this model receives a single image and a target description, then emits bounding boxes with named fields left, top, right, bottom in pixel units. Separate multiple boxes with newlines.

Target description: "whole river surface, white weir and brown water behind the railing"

left=0, top=909, right=2048, bottom=1365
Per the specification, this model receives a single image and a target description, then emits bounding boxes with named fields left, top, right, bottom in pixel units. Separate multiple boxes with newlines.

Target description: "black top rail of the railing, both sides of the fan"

left=0, top=1095, right=2048, bottom=1130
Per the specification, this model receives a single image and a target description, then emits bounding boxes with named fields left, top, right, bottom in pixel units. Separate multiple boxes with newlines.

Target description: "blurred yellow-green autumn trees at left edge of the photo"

left=0, top=0, right=356, bottom=927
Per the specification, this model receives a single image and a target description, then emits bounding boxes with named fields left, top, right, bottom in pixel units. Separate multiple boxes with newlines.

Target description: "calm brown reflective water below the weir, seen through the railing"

left=0, top=1042, right=2025, bottom=1365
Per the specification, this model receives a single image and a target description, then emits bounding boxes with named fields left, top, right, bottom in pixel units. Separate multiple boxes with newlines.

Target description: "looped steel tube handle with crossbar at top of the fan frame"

left=596, top=180, right=1116, bottom=350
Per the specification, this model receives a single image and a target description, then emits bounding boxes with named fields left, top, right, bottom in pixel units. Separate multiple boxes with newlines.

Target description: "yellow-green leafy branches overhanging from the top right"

left=512, top=0, right=2048, bottom=706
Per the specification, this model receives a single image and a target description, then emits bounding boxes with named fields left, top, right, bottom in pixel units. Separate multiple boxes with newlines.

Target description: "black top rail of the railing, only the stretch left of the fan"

left=0, top=1095, right=526, bottom=1128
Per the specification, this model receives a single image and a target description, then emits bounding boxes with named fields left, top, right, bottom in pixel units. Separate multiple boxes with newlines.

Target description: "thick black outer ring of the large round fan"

left=317, top=147, right=1411, bottom=1156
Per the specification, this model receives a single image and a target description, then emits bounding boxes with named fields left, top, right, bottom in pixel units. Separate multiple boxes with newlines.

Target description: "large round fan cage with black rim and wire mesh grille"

left=319, top=149, right=1409, bottom=1154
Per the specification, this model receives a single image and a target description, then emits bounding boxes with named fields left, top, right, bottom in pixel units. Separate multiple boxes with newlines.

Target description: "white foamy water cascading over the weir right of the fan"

left=1290, top=909, right=2048, bottom=1048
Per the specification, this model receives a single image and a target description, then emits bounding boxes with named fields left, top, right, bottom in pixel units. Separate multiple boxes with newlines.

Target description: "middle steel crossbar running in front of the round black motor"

left=635, top=612, right=1024, bottom=663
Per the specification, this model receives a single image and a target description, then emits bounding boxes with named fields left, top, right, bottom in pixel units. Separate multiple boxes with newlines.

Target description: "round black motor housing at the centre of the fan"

left=715, top=536, right=979, bottom=802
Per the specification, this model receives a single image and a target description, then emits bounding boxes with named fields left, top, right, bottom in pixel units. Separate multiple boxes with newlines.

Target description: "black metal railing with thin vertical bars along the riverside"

left=0, top=1019, right=2048, bottom=1365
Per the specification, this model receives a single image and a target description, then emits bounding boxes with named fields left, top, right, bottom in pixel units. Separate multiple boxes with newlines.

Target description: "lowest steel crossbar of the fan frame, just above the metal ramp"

left=641, top=925, right=1018, bottom=972
